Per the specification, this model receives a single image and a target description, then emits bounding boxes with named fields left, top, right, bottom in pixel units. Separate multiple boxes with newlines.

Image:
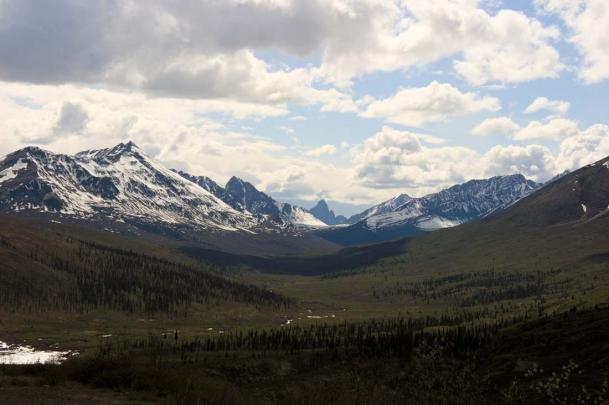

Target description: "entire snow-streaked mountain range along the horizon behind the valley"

left=0, top=142, right=541, bottom=246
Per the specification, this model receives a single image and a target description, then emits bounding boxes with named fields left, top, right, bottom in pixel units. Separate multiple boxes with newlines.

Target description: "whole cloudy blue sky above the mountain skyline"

left=0, top=0, right=609, bottom=214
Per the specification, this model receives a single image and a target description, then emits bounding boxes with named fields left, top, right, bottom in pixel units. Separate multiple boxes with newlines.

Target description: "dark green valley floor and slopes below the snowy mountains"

left=0, top=147, right=609, bottom=404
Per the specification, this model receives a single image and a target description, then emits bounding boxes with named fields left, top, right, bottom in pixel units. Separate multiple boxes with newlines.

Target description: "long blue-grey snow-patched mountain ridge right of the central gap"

left=318, top=174, right=540, bottom=245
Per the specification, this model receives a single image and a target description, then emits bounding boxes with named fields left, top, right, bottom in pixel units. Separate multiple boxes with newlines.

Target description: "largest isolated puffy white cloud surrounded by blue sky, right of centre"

left=361, top=81, right=501, bottom=127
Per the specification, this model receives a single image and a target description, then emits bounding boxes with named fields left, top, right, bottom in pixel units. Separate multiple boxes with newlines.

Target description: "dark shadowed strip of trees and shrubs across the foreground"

left=0, top=307, right=609, bottom=404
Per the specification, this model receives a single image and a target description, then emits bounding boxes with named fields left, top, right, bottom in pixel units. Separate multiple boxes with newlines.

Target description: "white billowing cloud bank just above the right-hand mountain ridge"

left=352, top=120, right=609, bottom=196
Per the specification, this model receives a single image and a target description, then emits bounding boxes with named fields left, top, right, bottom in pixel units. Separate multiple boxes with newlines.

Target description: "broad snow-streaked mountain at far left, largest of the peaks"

left=0, top=142, right=260, bottom=231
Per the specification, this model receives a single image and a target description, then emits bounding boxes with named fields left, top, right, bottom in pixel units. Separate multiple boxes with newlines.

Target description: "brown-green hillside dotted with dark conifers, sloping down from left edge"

left=0, top=217, right=290, bottom=316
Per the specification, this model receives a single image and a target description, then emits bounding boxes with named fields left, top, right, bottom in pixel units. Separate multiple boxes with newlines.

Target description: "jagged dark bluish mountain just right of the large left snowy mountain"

left=178, top=171, right=326, bottom=227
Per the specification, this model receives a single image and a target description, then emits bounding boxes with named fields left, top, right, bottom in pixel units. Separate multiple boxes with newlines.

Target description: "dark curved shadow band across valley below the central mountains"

left=179, top=239, right=409, bottom=276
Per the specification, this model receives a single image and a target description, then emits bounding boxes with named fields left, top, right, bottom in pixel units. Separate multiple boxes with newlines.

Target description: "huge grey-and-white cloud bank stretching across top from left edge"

left=0, top=0, right=562, bottom=103
